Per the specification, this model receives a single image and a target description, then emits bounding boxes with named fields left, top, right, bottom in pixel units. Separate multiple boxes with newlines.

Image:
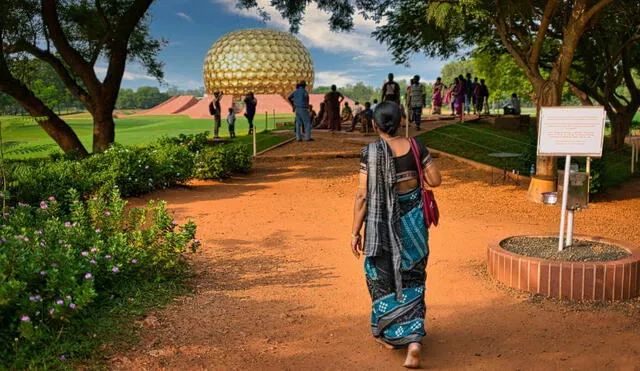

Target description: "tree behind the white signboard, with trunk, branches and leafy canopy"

left=374, top=0, right=613, bottom=202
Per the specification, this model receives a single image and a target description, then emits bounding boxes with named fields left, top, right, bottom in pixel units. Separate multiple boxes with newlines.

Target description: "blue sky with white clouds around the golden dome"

left=105, top=0, right=446, bottom=90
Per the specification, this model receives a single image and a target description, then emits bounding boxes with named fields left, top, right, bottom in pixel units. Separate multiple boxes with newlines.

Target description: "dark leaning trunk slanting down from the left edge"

left=0, top=76, right=88, bottom=156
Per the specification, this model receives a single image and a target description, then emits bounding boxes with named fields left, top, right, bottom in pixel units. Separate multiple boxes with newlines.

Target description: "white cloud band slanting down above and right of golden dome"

left=210, top=0, right=392, bottom=63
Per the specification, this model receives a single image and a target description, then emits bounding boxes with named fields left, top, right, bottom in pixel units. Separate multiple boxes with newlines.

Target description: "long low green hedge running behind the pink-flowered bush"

left=8, top=133, right=251, bottom=204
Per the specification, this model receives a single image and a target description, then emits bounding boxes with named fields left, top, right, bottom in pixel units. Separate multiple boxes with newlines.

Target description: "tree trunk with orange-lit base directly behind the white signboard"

left=527, top=80, right=564, bottom=202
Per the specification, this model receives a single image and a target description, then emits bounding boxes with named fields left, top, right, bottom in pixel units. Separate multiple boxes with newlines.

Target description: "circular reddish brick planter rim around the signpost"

left=487, top=235, right=640, bottom=300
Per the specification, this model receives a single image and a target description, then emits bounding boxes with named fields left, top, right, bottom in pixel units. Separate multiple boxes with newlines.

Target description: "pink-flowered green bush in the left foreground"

left=0, top=189, right=199, bottom=368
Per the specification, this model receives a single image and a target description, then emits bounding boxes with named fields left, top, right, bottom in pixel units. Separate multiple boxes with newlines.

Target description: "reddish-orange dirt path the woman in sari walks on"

left=111, top=141, right=640, bottom=370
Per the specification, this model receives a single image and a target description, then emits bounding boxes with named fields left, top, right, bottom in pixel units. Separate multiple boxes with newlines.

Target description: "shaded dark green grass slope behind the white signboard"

left=420, top=123, right=631, bottom=192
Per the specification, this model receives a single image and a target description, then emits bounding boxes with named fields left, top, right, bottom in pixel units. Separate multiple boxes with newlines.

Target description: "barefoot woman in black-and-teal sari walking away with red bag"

left=351, top=102, right=440, bottom=368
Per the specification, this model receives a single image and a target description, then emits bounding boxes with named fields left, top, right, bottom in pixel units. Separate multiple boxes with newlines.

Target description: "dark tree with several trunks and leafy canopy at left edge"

left=0, top=0, right=163, bottom=154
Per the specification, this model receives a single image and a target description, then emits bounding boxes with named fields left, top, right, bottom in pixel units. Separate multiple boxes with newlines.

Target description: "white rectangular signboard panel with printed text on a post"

left=538, top=107, right=606, bottom=157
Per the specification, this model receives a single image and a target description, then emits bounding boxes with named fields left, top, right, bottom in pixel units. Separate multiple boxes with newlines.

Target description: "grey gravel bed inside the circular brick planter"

left=500, top=237, right=631, bottom=262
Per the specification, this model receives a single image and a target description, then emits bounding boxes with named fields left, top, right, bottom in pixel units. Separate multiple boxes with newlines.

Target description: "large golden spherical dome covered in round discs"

left=203, top=28, right=313, bottom=98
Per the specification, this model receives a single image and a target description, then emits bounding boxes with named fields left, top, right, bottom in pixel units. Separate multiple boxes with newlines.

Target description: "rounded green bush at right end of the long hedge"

left=194, top=145, right=252, bottom=179
